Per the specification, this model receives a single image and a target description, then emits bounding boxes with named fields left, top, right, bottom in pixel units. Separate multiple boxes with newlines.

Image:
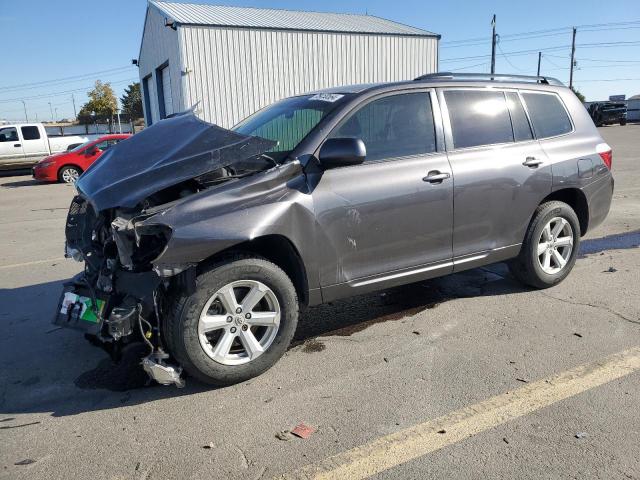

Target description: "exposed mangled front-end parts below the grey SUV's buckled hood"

left=54, top=195, right=189, bottom=387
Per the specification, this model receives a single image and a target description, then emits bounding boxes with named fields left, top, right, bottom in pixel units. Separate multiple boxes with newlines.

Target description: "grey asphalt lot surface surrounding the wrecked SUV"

left=0, top=125, right=640, bottom=479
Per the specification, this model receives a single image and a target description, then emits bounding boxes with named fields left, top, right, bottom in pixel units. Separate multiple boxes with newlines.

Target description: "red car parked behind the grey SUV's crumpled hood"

left=33, top=134, right=131, bottom=183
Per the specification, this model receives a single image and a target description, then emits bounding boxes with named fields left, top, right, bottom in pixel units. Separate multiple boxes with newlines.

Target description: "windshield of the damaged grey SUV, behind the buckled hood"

left=231, top=93, right=346, bottom=162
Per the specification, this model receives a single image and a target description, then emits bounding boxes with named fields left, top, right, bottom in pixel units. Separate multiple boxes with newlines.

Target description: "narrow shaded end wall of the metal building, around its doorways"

left=138, top=8, right=184, bottom=122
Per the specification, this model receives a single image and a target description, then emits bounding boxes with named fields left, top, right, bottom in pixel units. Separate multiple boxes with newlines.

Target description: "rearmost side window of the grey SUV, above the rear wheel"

left=522, top=93, right=572, bottom=138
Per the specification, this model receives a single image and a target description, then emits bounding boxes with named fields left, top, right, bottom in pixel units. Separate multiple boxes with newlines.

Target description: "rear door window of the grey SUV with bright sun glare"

left=444, top=90, right=513, bottom=148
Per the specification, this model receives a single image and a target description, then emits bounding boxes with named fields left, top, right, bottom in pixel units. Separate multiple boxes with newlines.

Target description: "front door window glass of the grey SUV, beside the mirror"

left=330, top=92, right=436, bottom=161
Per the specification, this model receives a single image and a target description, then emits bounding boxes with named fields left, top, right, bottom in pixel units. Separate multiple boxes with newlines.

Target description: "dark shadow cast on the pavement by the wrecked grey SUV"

left=0, top=231, right=640, bottom=416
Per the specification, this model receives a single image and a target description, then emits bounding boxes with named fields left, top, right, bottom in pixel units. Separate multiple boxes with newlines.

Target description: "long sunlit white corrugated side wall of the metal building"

left=178, top=25, right=438, bottom=127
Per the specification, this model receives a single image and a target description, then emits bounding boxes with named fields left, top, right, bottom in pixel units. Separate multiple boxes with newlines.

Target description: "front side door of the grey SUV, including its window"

left=313, top=87, right=453, bottom=294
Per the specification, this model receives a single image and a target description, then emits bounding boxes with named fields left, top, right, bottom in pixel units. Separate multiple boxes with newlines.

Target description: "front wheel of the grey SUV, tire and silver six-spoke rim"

left=167, top=255, right=298, bottom=386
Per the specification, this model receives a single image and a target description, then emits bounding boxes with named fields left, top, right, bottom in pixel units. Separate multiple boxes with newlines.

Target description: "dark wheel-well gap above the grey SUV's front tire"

left=197, top=234, right=309, bottom=306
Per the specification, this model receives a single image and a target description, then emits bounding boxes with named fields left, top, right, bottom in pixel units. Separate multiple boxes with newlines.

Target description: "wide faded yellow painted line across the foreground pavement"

left=281, top=347, right=640, bottom=480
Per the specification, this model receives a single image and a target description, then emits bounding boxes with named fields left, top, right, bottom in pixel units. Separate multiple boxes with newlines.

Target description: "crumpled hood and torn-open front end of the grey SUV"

left=54, top=115, right=277, bottom=387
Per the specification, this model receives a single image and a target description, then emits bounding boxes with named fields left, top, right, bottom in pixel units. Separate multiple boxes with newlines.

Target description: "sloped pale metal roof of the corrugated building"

left=149, top=1, right=440, bottom=38
